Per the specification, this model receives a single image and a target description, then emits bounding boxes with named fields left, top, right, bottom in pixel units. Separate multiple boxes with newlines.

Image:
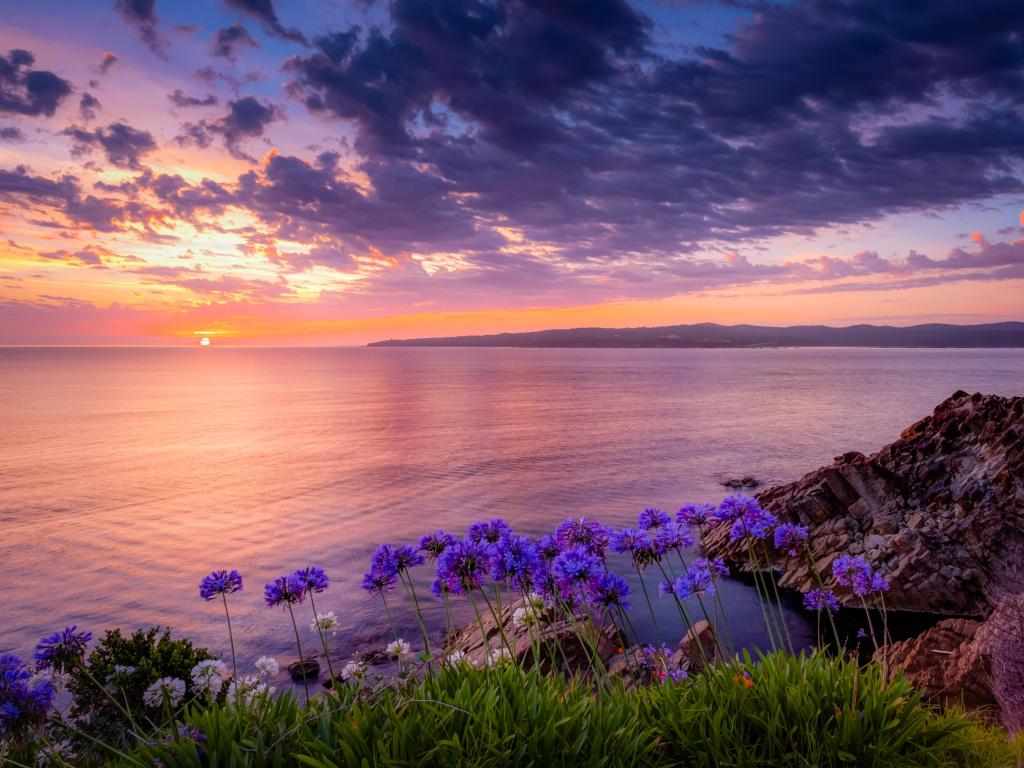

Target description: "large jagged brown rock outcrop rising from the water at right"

left=707, top=391, right=1024, bottom=615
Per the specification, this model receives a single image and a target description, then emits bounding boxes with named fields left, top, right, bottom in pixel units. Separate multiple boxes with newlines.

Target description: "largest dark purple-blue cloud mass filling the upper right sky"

left=276, top=0, right=1024, bottom=264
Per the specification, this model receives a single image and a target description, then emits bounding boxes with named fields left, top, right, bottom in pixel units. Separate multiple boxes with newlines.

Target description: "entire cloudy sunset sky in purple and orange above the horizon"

left=0, top=0, right=1024, bottom=345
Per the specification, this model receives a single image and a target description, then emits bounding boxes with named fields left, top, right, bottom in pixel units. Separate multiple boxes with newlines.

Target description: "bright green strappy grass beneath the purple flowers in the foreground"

left=114, top=654, right=1024, bottom=768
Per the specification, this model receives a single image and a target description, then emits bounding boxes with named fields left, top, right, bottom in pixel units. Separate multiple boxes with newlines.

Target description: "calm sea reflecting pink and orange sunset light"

left=0, top=348, right=1024, bottom=671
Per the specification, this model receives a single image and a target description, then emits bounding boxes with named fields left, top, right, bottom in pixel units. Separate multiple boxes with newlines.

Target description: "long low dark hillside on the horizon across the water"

left=369, top=323, right=1024, bottom=348
